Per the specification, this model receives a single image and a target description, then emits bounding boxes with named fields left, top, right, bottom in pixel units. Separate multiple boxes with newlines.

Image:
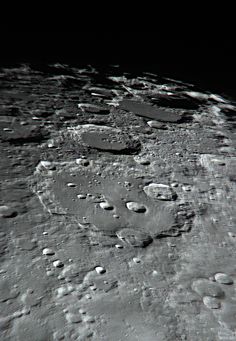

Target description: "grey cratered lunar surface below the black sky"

left=0, top=63, right=236, bottom=341
